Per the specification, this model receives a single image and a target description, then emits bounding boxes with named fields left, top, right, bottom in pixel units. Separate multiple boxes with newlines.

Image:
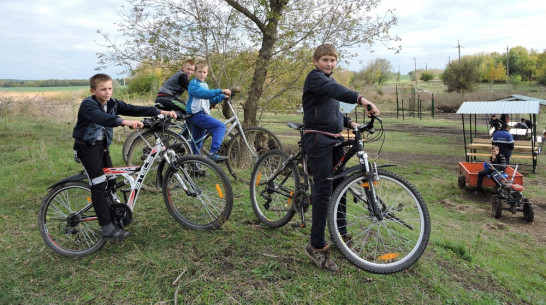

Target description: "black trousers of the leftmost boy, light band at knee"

left=74, top=140, right=115, bottom=226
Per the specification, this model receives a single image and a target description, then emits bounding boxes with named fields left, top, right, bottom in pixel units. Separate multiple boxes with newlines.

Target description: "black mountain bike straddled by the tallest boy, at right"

left=250, top=114, right=431, bottom=274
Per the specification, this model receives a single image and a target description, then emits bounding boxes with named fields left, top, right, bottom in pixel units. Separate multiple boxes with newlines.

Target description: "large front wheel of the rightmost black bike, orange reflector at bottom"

left=328, top=170, right=431, bottom=274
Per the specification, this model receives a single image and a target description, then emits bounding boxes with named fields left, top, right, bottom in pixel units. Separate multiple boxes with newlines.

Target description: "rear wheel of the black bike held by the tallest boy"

left=250, top=149, right=300, bottom=228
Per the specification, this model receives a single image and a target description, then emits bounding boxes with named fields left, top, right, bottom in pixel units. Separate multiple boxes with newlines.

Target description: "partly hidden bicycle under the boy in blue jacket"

left=122, top=96, right=282, bottom=186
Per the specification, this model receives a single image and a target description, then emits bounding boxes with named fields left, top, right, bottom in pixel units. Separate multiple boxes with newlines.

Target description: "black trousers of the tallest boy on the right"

left=303, top=133, right=347, bottom=249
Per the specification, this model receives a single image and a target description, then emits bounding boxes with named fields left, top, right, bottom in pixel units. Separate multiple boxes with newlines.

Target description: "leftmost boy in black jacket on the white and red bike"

left=72, top=73, right=176, bottom=241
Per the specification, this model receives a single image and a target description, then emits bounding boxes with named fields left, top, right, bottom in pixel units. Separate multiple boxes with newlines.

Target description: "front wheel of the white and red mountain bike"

left=163, top=155, right=233, bottom=230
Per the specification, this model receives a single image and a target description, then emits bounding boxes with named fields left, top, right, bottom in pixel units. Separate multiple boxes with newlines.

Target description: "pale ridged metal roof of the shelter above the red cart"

left=457, top=100, right=536, bottom=114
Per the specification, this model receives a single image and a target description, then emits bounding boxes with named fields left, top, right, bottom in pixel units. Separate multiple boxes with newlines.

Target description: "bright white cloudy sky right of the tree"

left=344, top=0, right=546, bottom=74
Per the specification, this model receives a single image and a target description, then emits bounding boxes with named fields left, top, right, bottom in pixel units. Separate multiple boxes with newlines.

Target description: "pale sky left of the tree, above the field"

left=0, top=0, right=123, bottom=79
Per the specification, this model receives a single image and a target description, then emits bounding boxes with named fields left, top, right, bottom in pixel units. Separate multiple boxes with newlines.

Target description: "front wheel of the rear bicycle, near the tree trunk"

left=226, top=126, right=282, bottom=184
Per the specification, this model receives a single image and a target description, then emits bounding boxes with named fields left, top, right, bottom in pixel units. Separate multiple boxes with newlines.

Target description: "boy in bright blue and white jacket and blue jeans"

left=186, top=62, right=231, bottom=162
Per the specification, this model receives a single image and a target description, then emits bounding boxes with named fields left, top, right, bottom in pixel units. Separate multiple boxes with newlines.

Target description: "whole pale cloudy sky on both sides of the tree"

left=0, top=0, right=546, bottom=80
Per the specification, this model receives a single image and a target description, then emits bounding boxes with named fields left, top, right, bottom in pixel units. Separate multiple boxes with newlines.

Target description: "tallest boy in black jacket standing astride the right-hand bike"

left=302, top=44, right=379, bottom=271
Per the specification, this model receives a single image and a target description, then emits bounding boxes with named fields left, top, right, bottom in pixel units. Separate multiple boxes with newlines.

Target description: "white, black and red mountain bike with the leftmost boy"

left=38, top=115, right=233, bottom=257
